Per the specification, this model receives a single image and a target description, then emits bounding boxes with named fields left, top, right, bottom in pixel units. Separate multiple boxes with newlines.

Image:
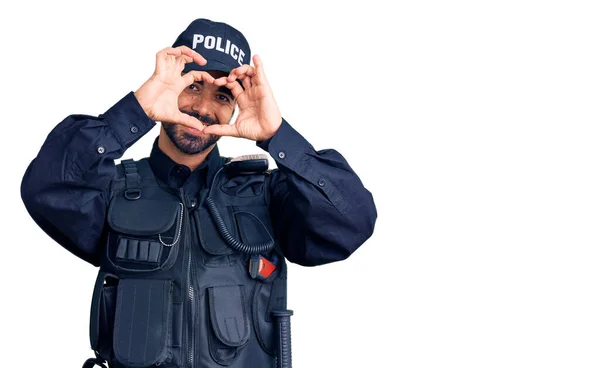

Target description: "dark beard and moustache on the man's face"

left=161, top=109, right=221, bottom=155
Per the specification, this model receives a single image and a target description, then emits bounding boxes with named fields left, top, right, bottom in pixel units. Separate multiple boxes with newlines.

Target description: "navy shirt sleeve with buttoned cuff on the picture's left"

left=21, top=92, right=155, bottom=266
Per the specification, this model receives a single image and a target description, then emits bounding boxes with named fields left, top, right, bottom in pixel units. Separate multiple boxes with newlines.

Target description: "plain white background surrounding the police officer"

left=0, top=0, right=600, bottom=368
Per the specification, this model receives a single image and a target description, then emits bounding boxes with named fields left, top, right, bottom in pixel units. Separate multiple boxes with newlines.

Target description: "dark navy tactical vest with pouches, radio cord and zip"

left=84, top=156, right=292, bottom=368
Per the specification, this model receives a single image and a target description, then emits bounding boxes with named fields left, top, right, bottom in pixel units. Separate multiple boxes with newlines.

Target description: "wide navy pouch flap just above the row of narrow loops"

left=108, top=195, right=181, bottom=235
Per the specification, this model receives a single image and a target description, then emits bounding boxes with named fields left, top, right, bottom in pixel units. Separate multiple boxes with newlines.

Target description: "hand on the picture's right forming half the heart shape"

left=203, top=55, right=282, bottom=141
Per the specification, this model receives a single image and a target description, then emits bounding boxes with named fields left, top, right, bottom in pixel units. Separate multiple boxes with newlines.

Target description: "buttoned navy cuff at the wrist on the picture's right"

left=256, top=118, right=313, bottom=168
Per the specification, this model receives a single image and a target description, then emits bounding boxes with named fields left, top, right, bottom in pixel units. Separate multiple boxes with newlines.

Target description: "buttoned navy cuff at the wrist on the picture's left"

left=98, top=91, right=156, bottom=148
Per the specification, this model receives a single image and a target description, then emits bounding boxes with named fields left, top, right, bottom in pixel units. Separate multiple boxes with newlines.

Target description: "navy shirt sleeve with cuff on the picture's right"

left=256, top=119, right=377, bottom=266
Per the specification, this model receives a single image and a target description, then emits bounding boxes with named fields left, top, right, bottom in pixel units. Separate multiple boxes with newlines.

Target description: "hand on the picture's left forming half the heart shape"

left=134, top=46, right=215, bottom=130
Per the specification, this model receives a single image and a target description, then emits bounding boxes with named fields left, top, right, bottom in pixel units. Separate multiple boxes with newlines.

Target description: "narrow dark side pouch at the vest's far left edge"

left=90, top=272, right=119, bottom=360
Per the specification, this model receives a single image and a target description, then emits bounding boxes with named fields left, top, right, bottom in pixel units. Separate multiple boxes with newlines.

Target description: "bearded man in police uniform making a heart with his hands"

left=21, top=19, right=377, bottom=367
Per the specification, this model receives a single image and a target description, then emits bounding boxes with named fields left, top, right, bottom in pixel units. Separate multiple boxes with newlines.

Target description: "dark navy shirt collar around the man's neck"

left=149, top=137, right=222, bottom=195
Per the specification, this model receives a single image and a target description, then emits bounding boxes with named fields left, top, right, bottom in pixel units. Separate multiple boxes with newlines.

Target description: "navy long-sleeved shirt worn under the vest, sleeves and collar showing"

left=21, top=92, right=377, bottom=266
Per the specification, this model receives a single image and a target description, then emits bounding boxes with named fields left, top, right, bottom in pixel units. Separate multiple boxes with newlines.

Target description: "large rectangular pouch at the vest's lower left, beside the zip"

left=111, top=279, right=173, bottom=368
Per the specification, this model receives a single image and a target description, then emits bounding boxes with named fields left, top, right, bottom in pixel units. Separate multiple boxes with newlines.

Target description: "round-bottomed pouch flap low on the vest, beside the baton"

left=208, top=285, right=250, bottom=347
